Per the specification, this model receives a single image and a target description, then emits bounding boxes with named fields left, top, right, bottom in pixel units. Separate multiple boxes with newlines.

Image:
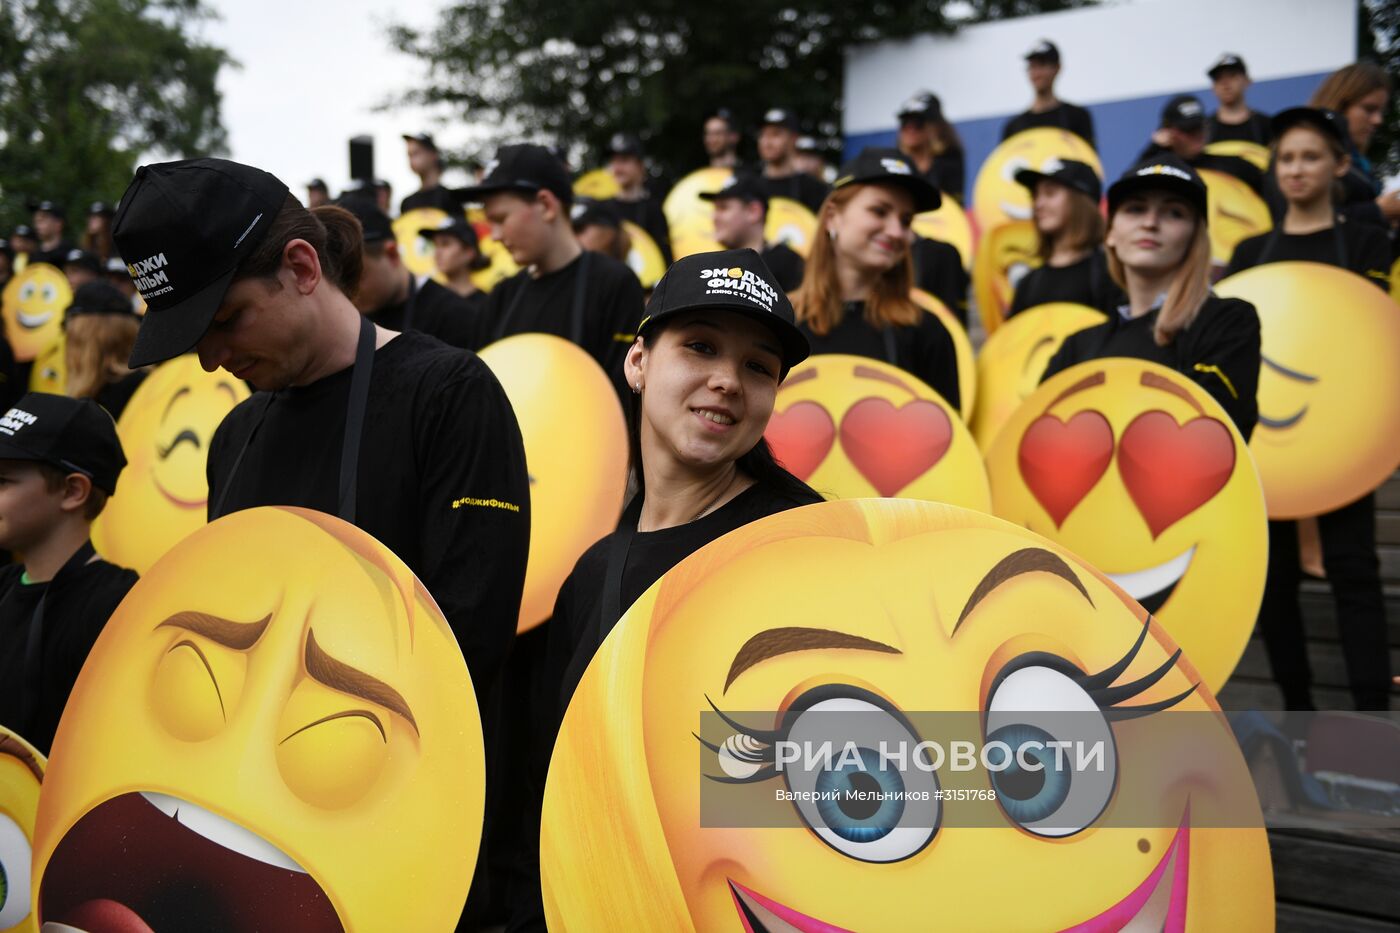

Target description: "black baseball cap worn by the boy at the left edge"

left=0, top=392, right=126, bottom=495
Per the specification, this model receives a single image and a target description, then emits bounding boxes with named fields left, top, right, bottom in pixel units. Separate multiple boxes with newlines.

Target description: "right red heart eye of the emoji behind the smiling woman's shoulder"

left=841, top=398, right=953, bottom=497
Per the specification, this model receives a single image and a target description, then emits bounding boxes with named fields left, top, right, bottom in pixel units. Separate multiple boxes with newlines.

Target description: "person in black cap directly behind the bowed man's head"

left=340, top=196, right=480, bottom=347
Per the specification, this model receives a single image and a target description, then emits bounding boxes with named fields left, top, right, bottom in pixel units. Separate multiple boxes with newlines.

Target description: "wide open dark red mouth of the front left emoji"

left=39, top=793, right=344, bottom=933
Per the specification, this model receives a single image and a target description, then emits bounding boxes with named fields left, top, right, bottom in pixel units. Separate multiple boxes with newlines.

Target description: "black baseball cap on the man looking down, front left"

left=112, top=158, right=287, bottom=368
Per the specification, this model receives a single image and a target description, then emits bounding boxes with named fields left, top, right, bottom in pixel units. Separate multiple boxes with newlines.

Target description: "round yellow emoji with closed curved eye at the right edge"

left=1215, top=262, right=1400, bottom=518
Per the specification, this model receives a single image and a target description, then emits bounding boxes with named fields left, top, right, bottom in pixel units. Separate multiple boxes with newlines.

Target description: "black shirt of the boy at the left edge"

left=0, top=549, right=136, bottom=755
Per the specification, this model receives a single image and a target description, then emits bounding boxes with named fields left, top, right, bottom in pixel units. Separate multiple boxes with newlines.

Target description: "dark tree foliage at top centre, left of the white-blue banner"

left=392, top=0, right=1091, bottom=172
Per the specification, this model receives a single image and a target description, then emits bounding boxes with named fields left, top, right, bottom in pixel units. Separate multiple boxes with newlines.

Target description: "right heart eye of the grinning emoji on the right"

left=1119, top=412, right=1235, bottom=538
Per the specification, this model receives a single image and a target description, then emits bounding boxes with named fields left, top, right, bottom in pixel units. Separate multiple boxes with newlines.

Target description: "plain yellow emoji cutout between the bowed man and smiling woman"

left=482, top=333, right=627, bottom=632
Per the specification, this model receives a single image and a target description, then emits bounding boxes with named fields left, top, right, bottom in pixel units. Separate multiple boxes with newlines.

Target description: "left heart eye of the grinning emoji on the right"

left=1018, top=410, right=1113, bottom=528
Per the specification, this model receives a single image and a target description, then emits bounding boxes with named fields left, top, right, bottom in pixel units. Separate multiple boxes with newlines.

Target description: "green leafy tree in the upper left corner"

left=0, top=0, right=232, bottom=237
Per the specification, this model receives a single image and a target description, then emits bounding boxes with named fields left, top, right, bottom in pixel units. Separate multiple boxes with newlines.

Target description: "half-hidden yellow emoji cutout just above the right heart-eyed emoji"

left=972, top=301, right=1106, bottom=452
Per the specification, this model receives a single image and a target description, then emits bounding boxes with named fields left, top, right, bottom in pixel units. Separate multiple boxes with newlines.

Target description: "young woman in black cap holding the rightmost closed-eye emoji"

left=1226, top=106, right=1390, bottom=710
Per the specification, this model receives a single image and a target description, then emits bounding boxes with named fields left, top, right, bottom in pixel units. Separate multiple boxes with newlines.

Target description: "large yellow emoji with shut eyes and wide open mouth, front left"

left=32, top=507, right=484, bottom=933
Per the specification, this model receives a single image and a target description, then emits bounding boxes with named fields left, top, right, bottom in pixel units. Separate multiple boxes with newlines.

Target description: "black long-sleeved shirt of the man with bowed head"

left=207, top=331, right=529, bottom=699
